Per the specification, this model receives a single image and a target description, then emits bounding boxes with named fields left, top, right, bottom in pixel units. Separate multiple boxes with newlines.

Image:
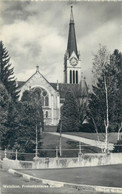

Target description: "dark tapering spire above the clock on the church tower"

left=67, top=6, right=79, bottom=58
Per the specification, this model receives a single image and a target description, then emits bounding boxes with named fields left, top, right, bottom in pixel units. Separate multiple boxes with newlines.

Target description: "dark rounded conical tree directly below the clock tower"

left=61, top=91, right=79, bottom=132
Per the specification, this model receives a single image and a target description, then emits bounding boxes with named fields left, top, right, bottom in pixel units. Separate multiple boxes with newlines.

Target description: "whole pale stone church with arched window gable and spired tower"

left=18, top=6, right=88, bottom=126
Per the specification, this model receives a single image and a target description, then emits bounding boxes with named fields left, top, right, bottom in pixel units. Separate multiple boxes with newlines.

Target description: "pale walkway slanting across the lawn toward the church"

left=47, top=132, right=114, bottom=150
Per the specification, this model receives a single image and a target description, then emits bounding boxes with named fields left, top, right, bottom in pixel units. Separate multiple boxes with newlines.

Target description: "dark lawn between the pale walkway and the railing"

left=40, top=133, right=100, bottom=157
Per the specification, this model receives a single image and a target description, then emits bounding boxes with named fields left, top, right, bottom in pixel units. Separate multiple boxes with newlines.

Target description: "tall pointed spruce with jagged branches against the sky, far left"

left=0, top=41, right=19, bottom=102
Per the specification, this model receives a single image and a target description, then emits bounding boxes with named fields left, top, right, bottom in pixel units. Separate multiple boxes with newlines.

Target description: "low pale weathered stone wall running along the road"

left=2, top=153, right=122, bottom=169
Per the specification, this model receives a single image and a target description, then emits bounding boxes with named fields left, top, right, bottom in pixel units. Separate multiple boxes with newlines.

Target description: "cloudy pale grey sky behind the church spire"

left=0, top=0, right=122, bottom=84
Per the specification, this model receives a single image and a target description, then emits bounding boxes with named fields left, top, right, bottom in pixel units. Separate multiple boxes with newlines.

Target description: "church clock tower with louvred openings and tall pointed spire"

left=64, top=6, right=81, bottom=84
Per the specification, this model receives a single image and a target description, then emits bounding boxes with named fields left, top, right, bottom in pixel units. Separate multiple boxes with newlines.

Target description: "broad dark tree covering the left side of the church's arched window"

left=2, top=90, right=44, bottom=156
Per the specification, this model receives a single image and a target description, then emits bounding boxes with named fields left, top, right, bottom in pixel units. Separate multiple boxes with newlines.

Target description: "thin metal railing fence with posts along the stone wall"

left=0, top=143, right=101, bottom=161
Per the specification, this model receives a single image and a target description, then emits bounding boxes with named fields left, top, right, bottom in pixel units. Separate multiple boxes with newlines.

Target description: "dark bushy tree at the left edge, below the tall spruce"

left=0, top=82, right=9, bottom=146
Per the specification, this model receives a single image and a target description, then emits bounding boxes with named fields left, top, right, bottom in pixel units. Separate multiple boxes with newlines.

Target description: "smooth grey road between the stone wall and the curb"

left=20, top=164, right=122, bottom=187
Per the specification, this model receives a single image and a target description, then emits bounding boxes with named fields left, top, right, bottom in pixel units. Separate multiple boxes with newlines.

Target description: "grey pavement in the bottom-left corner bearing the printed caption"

left=0, top=170, right=105, bottom=194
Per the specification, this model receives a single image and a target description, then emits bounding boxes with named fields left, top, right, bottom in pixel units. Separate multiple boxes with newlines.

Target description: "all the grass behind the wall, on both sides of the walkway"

left=1, top=132, right=119, bottom=161
